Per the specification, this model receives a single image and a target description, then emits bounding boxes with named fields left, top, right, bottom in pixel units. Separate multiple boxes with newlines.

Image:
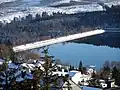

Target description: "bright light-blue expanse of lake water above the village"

left=43, top=43, right=120, bottom=69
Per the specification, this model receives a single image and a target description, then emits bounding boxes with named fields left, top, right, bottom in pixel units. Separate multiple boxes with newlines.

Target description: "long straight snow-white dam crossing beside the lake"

left=13, top=29, right=105, bottom=52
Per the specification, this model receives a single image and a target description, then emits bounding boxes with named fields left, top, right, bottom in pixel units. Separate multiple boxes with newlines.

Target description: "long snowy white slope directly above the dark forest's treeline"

left=0, top=4, right=103, bottom=23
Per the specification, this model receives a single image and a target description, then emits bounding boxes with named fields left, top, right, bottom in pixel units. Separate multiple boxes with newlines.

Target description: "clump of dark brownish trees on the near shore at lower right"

left=90, top=61, right=120, bottom=86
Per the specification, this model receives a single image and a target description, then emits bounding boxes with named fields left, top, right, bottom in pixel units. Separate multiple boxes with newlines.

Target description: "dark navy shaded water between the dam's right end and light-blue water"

left=73, top=32, right=120, bottom=48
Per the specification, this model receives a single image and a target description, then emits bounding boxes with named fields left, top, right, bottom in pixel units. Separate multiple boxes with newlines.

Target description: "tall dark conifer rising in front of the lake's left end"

left=33, top=48, right=58, bottom=90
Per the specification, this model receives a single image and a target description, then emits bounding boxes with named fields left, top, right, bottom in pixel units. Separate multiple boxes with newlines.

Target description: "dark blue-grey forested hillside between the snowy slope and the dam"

left=0, top=6, right=120, bottom=45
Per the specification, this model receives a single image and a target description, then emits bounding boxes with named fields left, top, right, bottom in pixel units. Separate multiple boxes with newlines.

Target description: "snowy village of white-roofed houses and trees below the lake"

left=0, top=44, right=119, bottom=90
